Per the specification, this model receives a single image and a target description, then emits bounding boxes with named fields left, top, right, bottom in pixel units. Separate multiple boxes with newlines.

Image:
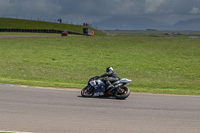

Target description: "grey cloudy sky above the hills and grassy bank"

left=0, top=0, right=200, bottom=24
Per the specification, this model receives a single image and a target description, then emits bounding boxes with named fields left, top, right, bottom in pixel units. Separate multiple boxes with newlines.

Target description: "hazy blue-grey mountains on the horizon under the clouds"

left=92, top=16, right=200, bottom=30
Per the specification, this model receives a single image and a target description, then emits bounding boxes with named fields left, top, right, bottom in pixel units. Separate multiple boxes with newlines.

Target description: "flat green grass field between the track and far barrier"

left=0, top=36, right=200, bottom=95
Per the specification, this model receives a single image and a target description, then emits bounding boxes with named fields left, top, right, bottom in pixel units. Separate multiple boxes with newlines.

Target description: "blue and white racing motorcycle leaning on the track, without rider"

left=81, top=77, right=132, bottom=99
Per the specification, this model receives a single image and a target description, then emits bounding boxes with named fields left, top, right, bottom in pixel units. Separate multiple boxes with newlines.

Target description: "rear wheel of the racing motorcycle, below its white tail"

left=115, top=86, right=130, bottom=99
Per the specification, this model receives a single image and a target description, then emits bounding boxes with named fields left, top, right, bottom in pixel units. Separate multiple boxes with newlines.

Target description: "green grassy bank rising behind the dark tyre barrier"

left=0, top=18, right=104, bottom=35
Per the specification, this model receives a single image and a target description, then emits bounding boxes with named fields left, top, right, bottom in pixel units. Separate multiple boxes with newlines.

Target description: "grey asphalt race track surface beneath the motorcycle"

left=0, top=84, right=200, bottom=133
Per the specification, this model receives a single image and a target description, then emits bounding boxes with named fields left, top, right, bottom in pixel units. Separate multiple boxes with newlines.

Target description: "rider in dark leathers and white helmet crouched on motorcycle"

left=97, top=67, right=120, bottom=90
